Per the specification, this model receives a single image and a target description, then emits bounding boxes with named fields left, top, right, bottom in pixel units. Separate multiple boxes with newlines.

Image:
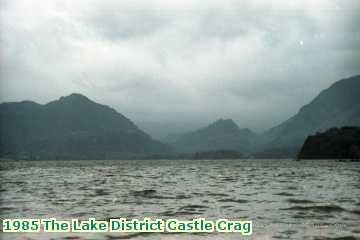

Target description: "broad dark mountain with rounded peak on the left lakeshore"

left=0, top=94, right=171, bottom=159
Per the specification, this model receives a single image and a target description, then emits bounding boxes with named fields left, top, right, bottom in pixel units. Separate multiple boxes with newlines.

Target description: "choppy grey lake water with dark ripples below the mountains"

left=0, top=159, right=360, bottom=240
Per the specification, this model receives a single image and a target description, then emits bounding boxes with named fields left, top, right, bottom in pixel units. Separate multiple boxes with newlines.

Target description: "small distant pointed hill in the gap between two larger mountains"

left=172, top=119, right=255, bottom=153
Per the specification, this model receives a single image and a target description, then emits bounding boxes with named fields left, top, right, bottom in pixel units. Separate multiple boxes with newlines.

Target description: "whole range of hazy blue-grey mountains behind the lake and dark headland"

left=0, top=76, right=360, bottom=159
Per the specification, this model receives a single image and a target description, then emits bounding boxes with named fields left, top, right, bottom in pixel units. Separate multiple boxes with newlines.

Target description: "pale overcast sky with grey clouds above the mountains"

left=0, top=0, right=360, bottom=136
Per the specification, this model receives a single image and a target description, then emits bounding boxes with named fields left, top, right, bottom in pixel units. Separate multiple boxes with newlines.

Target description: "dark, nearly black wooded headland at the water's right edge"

left=298, top=127, right=360, bottom=159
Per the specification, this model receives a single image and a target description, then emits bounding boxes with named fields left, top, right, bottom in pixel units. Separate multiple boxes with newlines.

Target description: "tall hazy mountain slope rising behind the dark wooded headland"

left=260, top=76, right=360, bottom=154
